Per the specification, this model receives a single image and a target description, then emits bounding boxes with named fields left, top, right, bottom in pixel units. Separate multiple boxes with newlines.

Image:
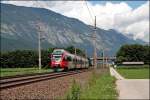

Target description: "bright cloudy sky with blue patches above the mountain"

left=2, top=1, right=149, bottom=42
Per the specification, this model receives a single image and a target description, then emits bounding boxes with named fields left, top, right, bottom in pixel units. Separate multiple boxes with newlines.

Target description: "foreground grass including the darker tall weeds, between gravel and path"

left=67, top=70, right=118, bottom=100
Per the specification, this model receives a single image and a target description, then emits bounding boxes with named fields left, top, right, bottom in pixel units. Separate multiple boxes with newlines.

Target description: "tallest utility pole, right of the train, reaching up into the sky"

left=93, top=16, right=97, bottom=68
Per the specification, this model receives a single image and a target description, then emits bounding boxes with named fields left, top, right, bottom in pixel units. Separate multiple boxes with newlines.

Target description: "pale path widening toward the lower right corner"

left=110, top=68, right=150, bottom=99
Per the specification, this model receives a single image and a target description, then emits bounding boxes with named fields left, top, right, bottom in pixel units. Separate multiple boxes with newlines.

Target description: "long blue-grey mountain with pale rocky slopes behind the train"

left=0, top=3, right=145, bottom=55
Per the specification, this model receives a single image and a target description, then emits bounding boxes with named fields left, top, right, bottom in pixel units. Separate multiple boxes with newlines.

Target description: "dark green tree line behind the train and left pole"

left=0, top=46, right=85, bottom=68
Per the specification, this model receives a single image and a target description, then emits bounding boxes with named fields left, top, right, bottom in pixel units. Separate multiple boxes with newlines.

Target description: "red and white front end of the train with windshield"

left=50, top=49, right=64, bottom=69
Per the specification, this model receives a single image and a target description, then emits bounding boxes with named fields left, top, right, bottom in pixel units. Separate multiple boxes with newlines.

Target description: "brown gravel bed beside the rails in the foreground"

left=0, top=71, right=92, bottom=100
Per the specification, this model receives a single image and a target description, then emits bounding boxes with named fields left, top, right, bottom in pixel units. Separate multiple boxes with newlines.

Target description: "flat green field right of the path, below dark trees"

left=117, top=66, right=150, bottom=79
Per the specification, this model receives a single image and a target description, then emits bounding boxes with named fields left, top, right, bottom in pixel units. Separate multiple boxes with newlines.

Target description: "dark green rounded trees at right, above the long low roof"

left=116, top=44, right=150, bottom=64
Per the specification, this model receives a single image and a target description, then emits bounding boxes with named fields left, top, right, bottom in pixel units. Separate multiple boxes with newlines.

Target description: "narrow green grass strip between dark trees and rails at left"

left=0, top=68, right=52, bottom=77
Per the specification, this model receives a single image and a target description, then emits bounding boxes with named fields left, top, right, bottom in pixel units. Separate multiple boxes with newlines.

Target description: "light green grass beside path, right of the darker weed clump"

left=80, top=73, right=117, bottom=100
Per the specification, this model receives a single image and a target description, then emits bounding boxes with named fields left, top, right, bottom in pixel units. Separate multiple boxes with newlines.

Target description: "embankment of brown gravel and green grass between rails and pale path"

left=0, top=68, right=117, bottom=100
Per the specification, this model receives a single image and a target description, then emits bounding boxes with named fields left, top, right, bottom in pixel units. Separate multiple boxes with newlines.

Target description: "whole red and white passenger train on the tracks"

left=50, top=49, right=89, bottom=70
